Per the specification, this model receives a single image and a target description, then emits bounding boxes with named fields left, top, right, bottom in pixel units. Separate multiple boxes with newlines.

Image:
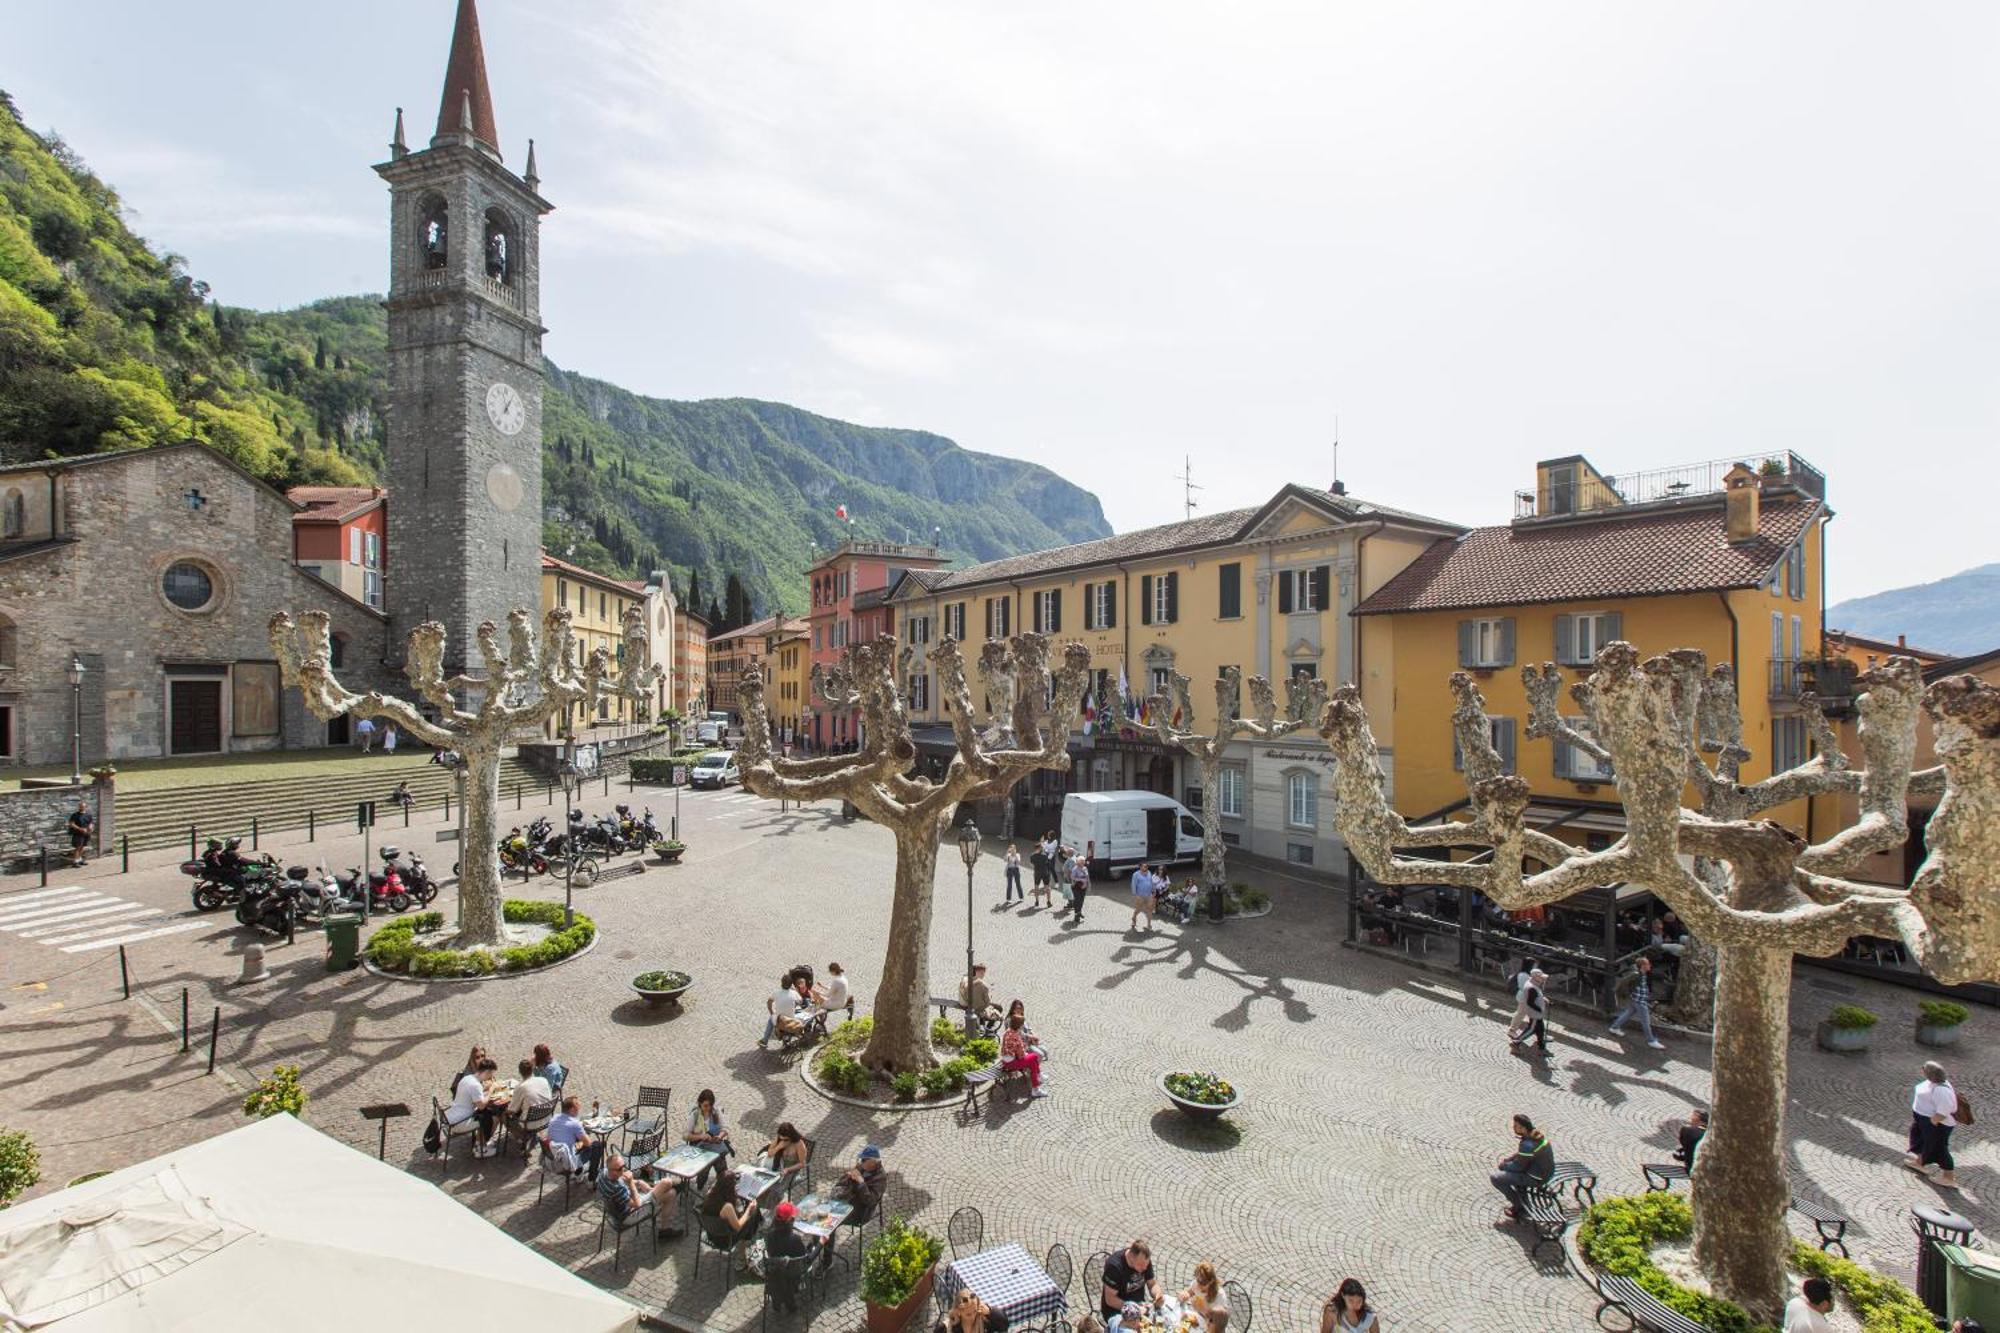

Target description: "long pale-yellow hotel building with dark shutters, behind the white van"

left=888, top=486, right=1460, bottom=867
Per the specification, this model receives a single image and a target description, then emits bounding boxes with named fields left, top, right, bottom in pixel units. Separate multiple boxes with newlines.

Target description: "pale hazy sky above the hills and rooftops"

left=0, top=0, right=2000, bottom=598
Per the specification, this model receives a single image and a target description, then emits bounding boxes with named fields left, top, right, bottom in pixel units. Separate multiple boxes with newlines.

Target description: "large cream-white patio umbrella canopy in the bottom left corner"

left=0, top=1115, right=638, bottom=1333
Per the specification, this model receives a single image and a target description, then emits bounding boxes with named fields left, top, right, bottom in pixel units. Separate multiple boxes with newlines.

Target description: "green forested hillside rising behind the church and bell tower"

left=0, top=94, right=1110, bottom=614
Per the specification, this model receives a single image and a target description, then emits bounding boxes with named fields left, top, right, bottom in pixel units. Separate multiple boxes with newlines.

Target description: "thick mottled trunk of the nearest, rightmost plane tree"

left=1694, top=947, right=1792, bottom=1321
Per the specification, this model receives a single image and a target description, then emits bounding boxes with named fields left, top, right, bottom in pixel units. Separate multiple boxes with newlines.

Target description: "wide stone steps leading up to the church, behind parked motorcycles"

left=116, top=755, right=560, bottom=851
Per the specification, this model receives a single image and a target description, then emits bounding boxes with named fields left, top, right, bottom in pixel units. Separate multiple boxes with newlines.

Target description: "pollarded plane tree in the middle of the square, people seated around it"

left=736, top=634, right=1090, bottom=1075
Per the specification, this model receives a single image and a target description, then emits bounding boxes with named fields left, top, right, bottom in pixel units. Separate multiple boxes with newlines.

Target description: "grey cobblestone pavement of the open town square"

left=0, top=772, right=2000, bottom=1329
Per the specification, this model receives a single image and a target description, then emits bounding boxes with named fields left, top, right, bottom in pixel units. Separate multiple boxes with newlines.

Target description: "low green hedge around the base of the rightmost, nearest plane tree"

left=1576, top=1191, right=1936, bottom=1333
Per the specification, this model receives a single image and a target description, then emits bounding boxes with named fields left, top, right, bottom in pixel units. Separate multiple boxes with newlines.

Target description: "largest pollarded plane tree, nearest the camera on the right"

left=1320, top=642, right=2000, bottom=1315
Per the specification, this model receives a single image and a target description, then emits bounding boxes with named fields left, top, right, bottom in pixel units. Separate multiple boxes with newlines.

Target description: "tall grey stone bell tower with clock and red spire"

left=374, top=0, right=552, bottom=673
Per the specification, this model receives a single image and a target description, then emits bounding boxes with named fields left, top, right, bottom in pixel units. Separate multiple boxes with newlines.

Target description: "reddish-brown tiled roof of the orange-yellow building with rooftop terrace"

left=1354, top=498, right=1824, bottom=616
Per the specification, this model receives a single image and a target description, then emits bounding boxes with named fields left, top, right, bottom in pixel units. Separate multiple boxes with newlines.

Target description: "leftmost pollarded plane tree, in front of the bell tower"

left=270, top=606, right=656, bottom=949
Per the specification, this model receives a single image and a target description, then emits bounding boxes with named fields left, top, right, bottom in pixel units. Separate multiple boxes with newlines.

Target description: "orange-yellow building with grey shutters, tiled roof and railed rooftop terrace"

left=1356, top=454, right=1832, bottom=841
